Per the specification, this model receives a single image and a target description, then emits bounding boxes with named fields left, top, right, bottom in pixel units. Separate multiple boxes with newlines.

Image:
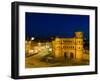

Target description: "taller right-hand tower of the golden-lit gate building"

left=75, top=32, right=83, bottom=60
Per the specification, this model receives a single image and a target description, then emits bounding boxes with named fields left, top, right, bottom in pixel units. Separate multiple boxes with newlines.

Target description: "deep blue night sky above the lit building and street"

left=25, top=12, right=89, bottom=38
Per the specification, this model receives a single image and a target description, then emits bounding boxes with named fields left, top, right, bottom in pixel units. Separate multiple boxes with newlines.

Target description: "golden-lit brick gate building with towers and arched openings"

left=52, top=32, right=84, bottom=60
